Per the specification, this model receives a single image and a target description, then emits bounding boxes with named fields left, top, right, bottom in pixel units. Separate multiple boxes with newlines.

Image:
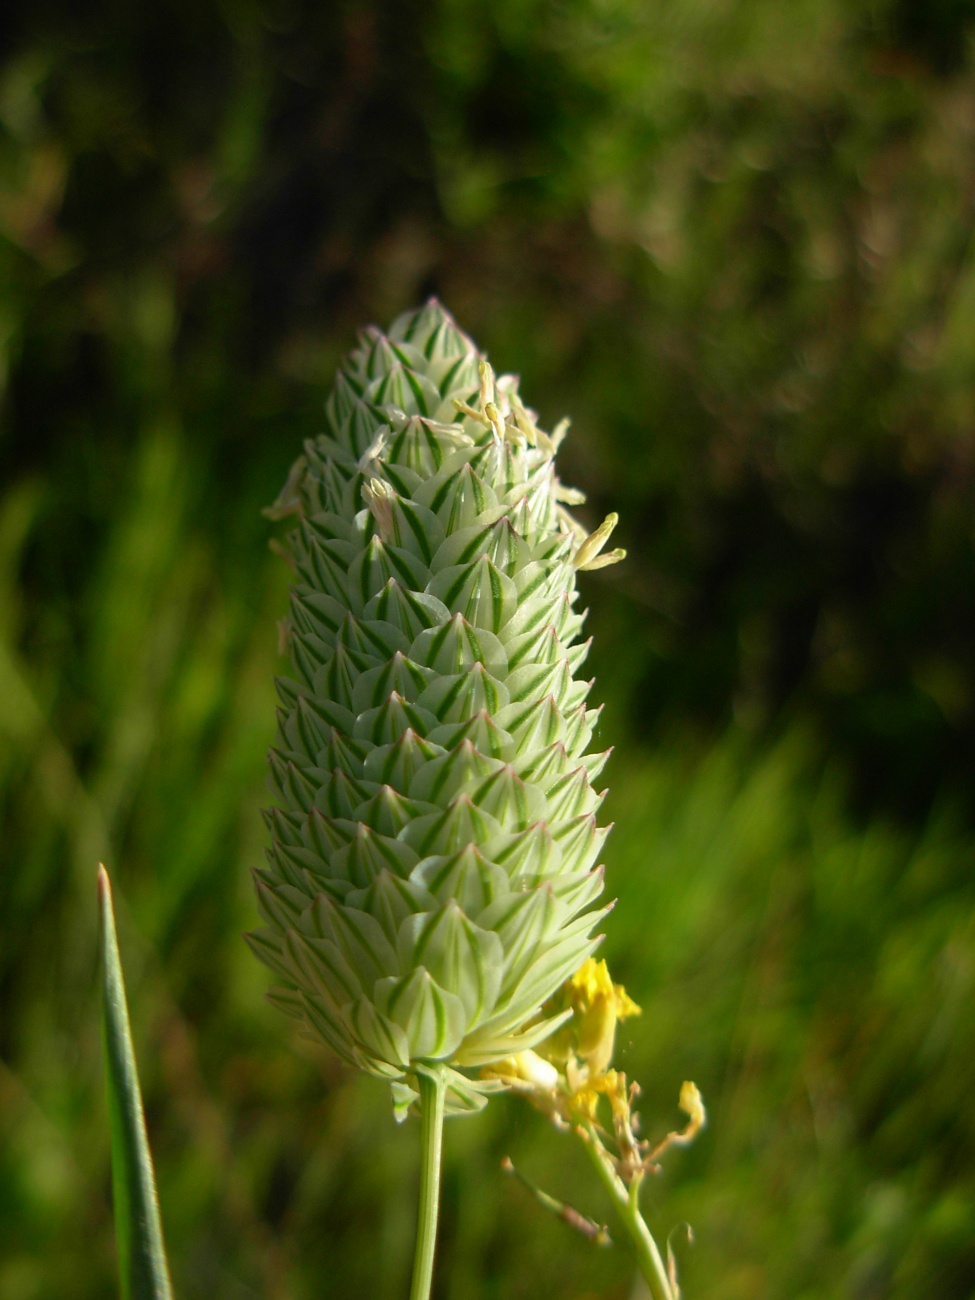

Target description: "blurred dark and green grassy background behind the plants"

left=0, top=0, right=975, bottom=1300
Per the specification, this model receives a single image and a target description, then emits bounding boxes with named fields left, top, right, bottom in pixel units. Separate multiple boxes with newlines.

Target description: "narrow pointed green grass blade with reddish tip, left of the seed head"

left=99, top=867, right=173, bottom=1300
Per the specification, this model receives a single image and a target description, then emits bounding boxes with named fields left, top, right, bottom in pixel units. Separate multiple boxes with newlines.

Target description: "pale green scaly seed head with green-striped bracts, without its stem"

left=248, top=302, right=621, bottom=1114
